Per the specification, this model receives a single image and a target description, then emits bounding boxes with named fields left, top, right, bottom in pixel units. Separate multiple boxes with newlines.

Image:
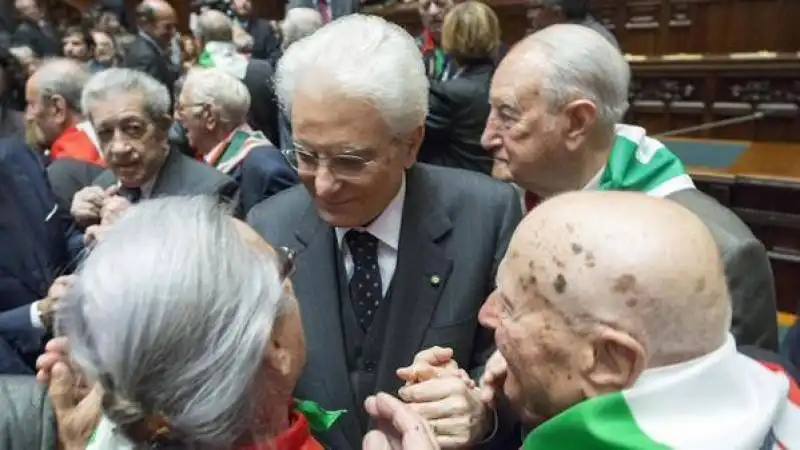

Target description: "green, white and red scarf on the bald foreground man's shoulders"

left=523, top=335, right=800, bottom=450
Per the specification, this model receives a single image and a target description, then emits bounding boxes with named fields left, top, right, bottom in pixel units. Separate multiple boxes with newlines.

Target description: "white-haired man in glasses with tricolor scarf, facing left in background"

left=175, top=68, right=297, bottom=214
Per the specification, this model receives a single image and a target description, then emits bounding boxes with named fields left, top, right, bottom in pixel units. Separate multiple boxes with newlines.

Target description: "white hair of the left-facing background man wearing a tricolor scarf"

left=183, top=68, right=250, bottom=126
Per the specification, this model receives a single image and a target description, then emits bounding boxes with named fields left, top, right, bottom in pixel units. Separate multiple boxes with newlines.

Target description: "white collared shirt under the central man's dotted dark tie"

left=336, top=175, right=406, bottom=297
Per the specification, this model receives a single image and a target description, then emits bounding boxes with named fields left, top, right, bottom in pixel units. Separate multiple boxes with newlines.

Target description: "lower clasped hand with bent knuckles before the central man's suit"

left=398, top=375, right=492, bottom=449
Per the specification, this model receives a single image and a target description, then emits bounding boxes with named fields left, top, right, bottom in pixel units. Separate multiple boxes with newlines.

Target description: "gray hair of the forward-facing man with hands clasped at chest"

left=81, top=68, right=172, bottom=120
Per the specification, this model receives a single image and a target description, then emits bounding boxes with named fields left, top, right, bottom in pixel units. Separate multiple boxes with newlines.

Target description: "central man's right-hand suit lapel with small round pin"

left=376, top=167, right=453, bottom=393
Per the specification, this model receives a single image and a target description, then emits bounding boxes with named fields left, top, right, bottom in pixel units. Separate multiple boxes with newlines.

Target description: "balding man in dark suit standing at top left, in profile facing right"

left=120, top=0, right=178, bottom=100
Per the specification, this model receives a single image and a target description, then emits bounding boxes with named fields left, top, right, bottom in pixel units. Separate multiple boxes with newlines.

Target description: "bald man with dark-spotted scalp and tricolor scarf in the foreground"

left=400, top=192, right=800, bottom=450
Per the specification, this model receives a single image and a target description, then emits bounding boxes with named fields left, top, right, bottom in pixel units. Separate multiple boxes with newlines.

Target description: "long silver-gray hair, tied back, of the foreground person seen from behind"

left=56, top=197, right=294, bottom=449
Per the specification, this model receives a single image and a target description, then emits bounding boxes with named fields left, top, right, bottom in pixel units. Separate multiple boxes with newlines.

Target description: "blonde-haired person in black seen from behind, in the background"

left=418, top=1, right=500, bottom=175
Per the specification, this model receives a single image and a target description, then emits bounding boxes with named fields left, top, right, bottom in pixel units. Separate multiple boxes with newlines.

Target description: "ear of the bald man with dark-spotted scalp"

left=586, top=328, right=647, bottom=397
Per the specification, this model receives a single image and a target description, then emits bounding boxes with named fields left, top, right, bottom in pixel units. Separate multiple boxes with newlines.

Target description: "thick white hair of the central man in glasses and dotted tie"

left=275, top=14, right=428, bottom=135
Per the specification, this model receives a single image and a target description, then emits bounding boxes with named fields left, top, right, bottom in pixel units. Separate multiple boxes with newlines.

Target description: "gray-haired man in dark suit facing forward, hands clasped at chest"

left=71, top=69, right=238, bottom=234
